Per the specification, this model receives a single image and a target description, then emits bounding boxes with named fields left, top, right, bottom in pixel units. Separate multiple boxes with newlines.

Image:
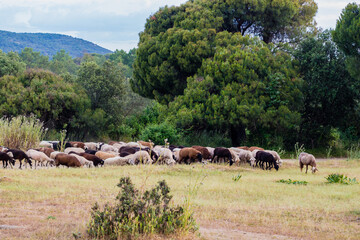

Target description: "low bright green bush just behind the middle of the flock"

left=140, top=122, right=181, bottom=145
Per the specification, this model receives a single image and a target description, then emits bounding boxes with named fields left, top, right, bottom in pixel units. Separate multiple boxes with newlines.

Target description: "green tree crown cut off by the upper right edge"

left=333, top=3, right=360, bottom=80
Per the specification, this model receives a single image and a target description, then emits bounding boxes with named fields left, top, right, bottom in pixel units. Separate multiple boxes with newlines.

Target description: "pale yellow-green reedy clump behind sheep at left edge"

left=0, top=116, right=46, bottom=149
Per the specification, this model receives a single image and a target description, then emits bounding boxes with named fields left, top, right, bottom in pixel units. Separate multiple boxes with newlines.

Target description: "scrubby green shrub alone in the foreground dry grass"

left=87, top=177, right=196, bottom=239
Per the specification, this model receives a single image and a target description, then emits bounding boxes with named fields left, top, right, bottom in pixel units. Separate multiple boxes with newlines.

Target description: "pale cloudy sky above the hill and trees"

left=0, top=0, right=360, bottom=51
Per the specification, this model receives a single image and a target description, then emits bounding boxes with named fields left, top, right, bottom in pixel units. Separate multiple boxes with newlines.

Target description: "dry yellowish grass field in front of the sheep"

left=0, top=159, right=360, bottom=240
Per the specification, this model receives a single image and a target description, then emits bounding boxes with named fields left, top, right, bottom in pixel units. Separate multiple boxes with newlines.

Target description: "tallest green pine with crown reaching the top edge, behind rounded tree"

left=131, top=0, right=317, bottom=103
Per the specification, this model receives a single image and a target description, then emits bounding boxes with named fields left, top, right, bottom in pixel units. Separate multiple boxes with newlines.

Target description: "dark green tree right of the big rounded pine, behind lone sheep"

left=294, top=31, right=359, bottom=147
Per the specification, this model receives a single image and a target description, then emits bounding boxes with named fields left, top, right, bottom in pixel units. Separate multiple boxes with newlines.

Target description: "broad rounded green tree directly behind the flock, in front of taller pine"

left=169, top=32, right=302, bottom=146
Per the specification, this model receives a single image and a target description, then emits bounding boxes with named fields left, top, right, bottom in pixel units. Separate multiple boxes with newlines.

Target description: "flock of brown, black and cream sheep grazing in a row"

left=0, top=141, right=317, bottom=173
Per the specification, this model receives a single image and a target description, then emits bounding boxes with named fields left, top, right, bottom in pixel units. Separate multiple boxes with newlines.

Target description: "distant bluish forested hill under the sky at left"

left=0, top=30, right=112, bottom=58
